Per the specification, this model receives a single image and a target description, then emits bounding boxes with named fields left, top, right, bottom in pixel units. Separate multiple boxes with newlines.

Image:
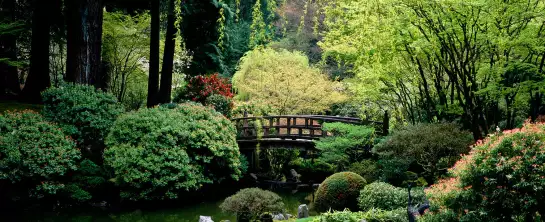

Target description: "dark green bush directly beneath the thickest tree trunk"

left=42, top=84, right=123, bottom=151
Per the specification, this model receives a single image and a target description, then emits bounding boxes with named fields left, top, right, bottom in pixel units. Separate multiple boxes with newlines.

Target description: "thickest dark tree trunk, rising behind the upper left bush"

left=64, top=0, right=107, bottom=88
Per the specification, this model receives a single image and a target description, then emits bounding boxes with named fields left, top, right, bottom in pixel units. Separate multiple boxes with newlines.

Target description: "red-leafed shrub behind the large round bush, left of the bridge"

left=174, top=73, right=233, bottom=104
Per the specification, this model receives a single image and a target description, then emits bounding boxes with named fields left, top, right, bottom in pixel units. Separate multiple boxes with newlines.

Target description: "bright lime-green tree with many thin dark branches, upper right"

left=318, top=0, right=545, bottom=139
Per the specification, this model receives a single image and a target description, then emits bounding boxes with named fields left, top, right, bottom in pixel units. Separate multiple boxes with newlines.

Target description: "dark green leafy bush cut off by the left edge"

left=0, top=111, right=81, bottom=198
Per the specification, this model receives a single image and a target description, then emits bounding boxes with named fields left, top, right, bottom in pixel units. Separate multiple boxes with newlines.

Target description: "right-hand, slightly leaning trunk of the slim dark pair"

left=159, top=0, right=177, bottom=103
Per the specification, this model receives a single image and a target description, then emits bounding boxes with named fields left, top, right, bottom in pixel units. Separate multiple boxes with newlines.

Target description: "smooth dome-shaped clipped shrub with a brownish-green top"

left=314, top=172, right=365, bottom=212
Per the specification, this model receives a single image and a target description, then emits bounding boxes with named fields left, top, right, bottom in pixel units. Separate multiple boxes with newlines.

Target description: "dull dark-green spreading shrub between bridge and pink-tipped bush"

left=374, top=123, right=473, bottom=181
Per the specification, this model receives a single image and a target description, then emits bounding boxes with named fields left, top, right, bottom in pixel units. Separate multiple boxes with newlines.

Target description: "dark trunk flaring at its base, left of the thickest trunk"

left=21, top=0, right=51, bottom=102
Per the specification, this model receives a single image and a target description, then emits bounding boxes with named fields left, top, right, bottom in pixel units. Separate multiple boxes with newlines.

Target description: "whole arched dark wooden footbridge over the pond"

left=232, top=112, right=389, bottom=149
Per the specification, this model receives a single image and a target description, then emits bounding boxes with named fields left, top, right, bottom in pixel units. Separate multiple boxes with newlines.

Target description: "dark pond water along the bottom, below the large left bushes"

left=2, top=192, right=313, bottom=222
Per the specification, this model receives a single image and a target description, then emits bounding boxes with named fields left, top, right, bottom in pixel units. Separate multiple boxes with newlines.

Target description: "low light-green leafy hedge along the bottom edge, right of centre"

left=312, top=208, right=408, bottom=222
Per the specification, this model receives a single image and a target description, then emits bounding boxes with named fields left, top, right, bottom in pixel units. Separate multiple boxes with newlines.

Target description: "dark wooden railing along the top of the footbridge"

left=232, top=114, right=388, bottom=140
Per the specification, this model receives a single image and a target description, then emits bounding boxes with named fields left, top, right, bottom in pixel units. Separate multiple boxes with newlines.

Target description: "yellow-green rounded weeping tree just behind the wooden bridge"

left=233, top=47, right=345, bottom=114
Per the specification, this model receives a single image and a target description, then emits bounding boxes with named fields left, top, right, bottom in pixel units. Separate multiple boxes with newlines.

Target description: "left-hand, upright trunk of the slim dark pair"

left=147, top=0, right=161, bottom=107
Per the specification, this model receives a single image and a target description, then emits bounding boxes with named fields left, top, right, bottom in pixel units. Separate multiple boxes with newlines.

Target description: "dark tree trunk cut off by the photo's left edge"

left=0, top=0, right=21, bottom=98
